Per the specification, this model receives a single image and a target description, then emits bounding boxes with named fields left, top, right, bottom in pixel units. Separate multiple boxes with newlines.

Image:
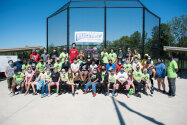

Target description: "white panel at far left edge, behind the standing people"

left=0, top=55, right=17, bottom=72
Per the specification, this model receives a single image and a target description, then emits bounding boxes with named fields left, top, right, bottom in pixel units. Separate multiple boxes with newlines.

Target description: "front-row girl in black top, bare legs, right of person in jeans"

left=48, top=68, right=60, bottom=96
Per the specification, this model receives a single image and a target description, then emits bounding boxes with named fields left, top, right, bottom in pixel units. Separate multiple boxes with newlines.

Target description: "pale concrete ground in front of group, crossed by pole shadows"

left=0, top=79, right=187, bottom=125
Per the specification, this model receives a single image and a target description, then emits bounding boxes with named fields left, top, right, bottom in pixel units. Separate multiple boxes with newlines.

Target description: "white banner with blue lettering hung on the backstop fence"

left=75, top=31, right=103, bottom=42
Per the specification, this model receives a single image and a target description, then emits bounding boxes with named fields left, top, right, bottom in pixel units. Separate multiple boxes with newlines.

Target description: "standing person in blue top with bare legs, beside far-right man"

left=155, top=58, right=166, bottom=93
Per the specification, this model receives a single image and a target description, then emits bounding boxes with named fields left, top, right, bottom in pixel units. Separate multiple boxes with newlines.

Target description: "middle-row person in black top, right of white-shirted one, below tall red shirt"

left=79, top=58, right=90, bottom=82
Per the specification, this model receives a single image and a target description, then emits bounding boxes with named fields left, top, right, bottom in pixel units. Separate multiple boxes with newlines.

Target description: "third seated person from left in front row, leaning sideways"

left=31, top=71, right=44, bottom=95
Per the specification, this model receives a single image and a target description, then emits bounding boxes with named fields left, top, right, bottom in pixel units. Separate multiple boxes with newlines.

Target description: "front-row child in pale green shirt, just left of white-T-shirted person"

left=106, top=69, right=117, bottom=96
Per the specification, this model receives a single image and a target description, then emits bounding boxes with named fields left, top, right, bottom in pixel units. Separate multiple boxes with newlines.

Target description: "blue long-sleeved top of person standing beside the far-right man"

left=155, top=63, right=166, bottom=78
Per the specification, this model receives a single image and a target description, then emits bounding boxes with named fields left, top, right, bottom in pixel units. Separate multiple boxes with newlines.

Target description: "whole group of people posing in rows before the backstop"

left=5, top=43, right=178, bottom=98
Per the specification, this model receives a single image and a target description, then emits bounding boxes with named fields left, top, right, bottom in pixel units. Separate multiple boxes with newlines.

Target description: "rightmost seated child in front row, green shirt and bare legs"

left=142, top=68, right=153, bottom=95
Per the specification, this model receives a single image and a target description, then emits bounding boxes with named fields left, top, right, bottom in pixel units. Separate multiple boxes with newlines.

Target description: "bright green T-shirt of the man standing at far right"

left=167, top=60, right=178, bottom=78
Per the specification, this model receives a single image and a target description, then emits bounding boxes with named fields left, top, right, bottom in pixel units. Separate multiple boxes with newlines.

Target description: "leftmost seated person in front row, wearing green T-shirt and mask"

left=11, top=69, right=25, bottom=96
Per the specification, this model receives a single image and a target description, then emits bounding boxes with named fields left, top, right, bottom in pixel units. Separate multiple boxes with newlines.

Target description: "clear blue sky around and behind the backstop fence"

left=0, top=0, right=187, bottom=48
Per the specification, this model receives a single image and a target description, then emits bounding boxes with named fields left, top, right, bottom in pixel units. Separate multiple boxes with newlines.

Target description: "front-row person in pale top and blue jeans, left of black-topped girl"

left=41, top=67, right=51, bottom=98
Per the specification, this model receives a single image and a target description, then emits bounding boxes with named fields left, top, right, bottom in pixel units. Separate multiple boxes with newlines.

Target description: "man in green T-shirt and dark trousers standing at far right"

left=167, top=56, right=178, bottom=97
